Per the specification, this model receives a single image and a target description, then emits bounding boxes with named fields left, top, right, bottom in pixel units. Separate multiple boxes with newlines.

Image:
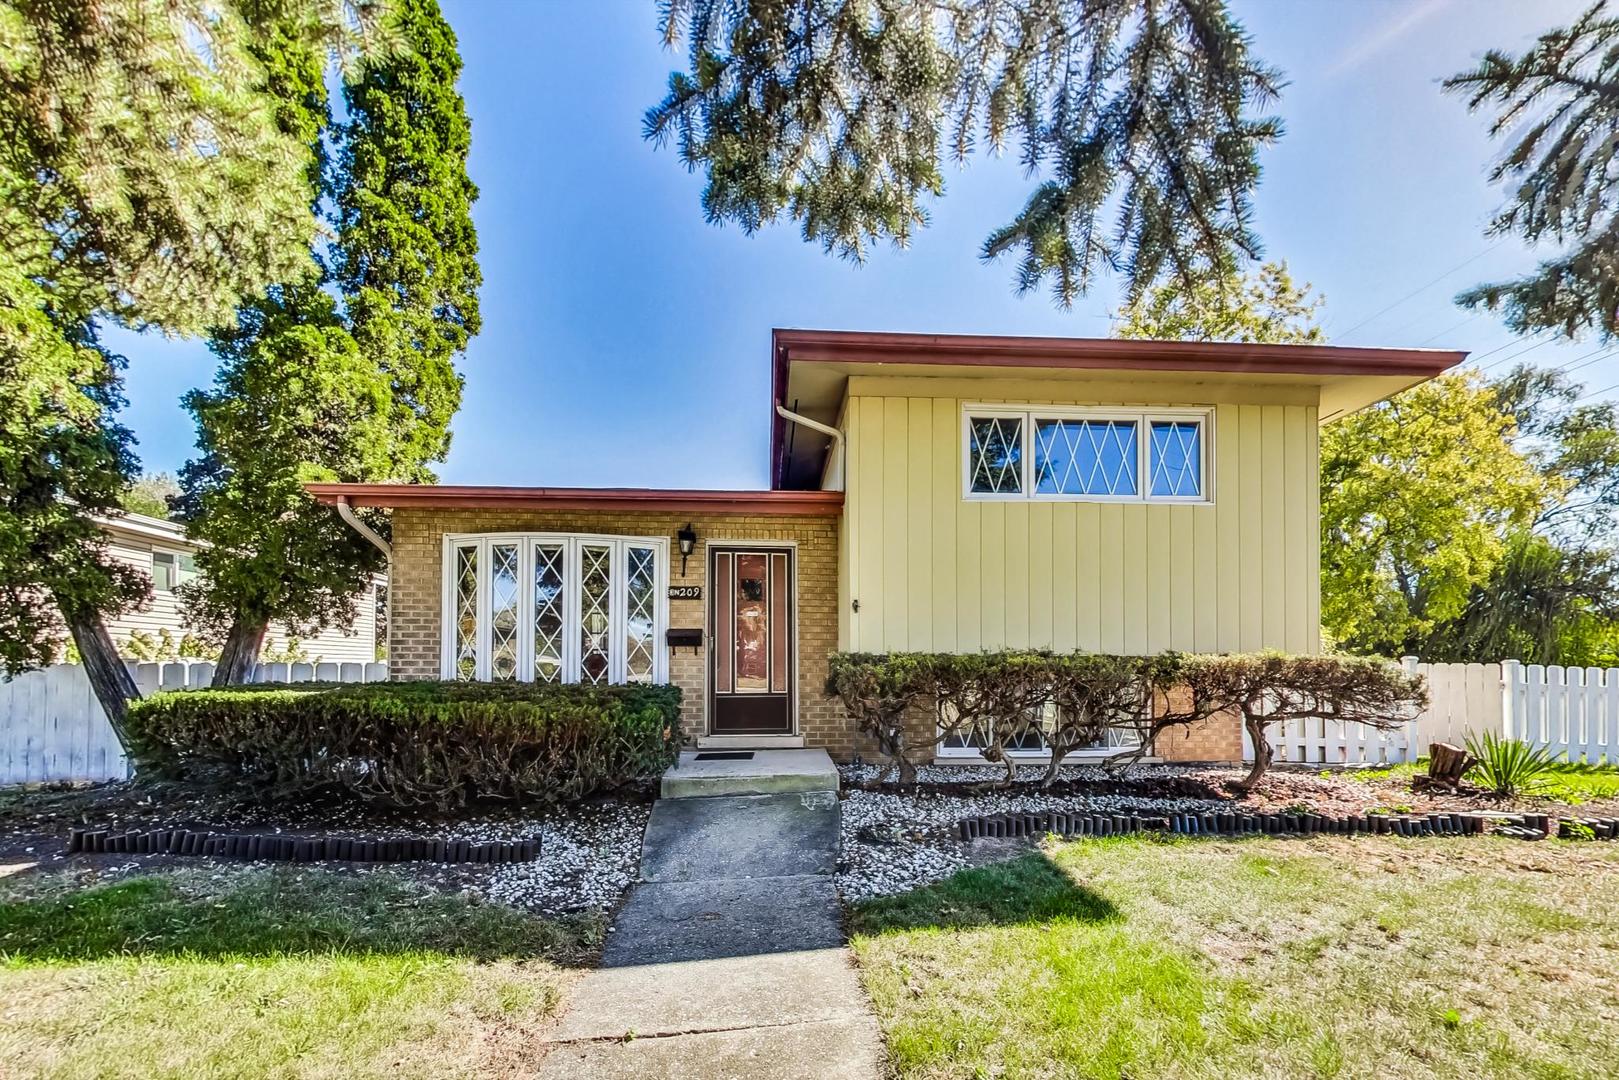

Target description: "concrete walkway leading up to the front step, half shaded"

left=539, top=792, right=882, bottom=1080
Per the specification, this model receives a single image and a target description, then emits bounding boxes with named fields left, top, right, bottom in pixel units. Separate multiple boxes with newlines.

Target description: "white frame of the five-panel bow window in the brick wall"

left=439, top=533, right=669, bottom=683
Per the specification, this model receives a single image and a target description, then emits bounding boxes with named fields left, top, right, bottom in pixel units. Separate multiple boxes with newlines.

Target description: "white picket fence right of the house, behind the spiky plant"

left=1269, top=656, right=1619, bottom=764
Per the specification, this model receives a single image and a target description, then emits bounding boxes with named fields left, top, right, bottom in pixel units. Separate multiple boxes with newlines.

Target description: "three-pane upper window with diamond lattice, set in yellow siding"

left=963, top=406, right=1213, bottom=502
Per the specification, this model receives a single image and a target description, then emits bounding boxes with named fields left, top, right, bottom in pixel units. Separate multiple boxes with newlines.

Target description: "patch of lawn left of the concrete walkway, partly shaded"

left=0, top=868, right=601, bottom=1078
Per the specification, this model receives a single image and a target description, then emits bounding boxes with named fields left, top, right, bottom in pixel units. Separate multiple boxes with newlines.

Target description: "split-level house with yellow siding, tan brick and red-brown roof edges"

left=309, top=330, right=1465, bottom=759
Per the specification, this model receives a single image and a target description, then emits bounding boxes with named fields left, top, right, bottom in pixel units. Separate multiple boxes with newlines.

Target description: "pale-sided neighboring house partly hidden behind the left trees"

left=96, top=513, right=387, bottom=664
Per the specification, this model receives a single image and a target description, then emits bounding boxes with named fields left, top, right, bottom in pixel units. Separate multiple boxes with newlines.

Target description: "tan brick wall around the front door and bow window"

left=389, top=507, right=855, bottom=759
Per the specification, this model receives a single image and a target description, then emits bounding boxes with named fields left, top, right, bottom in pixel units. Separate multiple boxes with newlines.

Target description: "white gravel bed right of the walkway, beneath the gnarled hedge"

left=837, top=766, right=1230, bottom=900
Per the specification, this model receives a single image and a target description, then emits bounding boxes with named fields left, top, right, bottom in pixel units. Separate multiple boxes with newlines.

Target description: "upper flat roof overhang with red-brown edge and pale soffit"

left=771, top=329, right=1467, bottom=486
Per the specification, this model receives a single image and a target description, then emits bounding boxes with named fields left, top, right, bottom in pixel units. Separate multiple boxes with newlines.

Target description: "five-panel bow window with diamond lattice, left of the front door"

left=444, top=534, right=669, bottom=683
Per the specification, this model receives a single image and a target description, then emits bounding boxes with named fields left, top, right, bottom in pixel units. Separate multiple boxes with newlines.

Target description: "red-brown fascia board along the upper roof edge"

left=771, top=329, right=1467, bottom=483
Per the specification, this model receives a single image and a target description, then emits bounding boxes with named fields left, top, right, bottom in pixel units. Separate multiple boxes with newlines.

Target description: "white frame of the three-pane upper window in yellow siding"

left=960, top=403, right=1214, bottom=507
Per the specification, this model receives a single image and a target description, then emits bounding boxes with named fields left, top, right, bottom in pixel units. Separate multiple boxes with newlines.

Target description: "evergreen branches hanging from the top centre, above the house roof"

left=644, top=0, right=1281, bottom=306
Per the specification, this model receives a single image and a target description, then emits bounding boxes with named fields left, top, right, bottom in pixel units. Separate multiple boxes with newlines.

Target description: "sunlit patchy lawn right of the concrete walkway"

left=853, top=837, right=1619, bottom=1080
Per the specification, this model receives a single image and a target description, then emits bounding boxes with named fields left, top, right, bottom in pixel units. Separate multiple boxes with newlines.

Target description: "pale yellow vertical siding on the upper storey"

left=842, top=390, right=1319, bottom=653
